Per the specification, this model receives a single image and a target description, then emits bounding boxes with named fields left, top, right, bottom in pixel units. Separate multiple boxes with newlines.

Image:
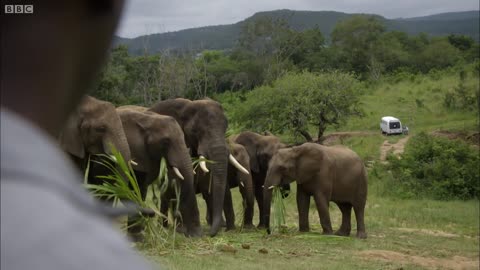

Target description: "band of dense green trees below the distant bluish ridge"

left=93, top=15, right=480, bottom=105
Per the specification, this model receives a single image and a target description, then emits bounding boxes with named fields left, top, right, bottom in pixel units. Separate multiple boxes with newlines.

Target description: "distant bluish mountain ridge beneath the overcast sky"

left=114, top=9, right=480, bottom=54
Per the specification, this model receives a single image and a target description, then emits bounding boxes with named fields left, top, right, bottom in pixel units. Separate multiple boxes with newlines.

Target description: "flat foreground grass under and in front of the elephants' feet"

left=138, top=185, right=479, bottom=269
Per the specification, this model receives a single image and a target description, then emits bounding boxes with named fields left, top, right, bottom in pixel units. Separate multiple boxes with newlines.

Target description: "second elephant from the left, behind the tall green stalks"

left=117, top=107, right=202, bottom=237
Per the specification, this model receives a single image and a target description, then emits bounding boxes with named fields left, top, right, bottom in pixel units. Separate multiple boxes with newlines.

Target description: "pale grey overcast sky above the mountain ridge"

left=117, top=0, right=479, bottom=37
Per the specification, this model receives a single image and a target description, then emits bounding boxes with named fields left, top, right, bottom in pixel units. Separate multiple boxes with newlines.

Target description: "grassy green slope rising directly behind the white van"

left=329, top=69, right=479, bottom=134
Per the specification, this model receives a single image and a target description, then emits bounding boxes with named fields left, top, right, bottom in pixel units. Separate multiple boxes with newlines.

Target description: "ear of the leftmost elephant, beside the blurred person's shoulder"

left=59, top=113, right=85, bottom=158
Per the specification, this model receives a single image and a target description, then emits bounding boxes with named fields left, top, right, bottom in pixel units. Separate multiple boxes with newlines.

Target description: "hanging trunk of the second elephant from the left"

left=167, top=147, right=202, bottom=237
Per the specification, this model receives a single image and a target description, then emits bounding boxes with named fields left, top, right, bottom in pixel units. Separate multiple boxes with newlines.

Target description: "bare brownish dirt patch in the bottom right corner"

left=358, top=250, right=478, bottom=270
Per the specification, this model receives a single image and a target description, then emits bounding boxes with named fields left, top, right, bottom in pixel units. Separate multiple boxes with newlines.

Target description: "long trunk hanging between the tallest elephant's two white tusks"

left=207, top=137, right=228, bottom=236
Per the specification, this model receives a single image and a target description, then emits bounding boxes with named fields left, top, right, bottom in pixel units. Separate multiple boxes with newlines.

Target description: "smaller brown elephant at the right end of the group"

left=263, top=143, right=367, bottom=238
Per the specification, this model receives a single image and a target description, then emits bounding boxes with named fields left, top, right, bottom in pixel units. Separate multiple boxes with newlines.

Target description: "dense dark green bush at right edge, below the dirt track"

left=389, top=133, right=480, bottom=200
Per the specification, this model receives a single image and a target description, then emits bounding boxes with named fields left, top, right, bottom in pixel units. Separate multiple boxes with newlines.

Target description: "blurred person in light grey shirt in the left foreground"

left=0, top=0, right=154, bottom=270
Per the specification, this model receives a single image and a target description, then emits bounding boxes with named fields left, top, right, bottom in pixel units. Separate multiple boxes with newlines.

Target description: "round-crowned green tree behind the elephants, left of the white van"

left=236, top=71, right=361, bottom=141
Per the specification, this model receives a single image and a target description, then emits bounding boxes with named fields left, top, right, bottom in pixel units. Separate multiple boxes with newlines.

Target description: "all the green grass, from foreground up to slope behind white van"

left=128, top=69, right=480, bottom=270
